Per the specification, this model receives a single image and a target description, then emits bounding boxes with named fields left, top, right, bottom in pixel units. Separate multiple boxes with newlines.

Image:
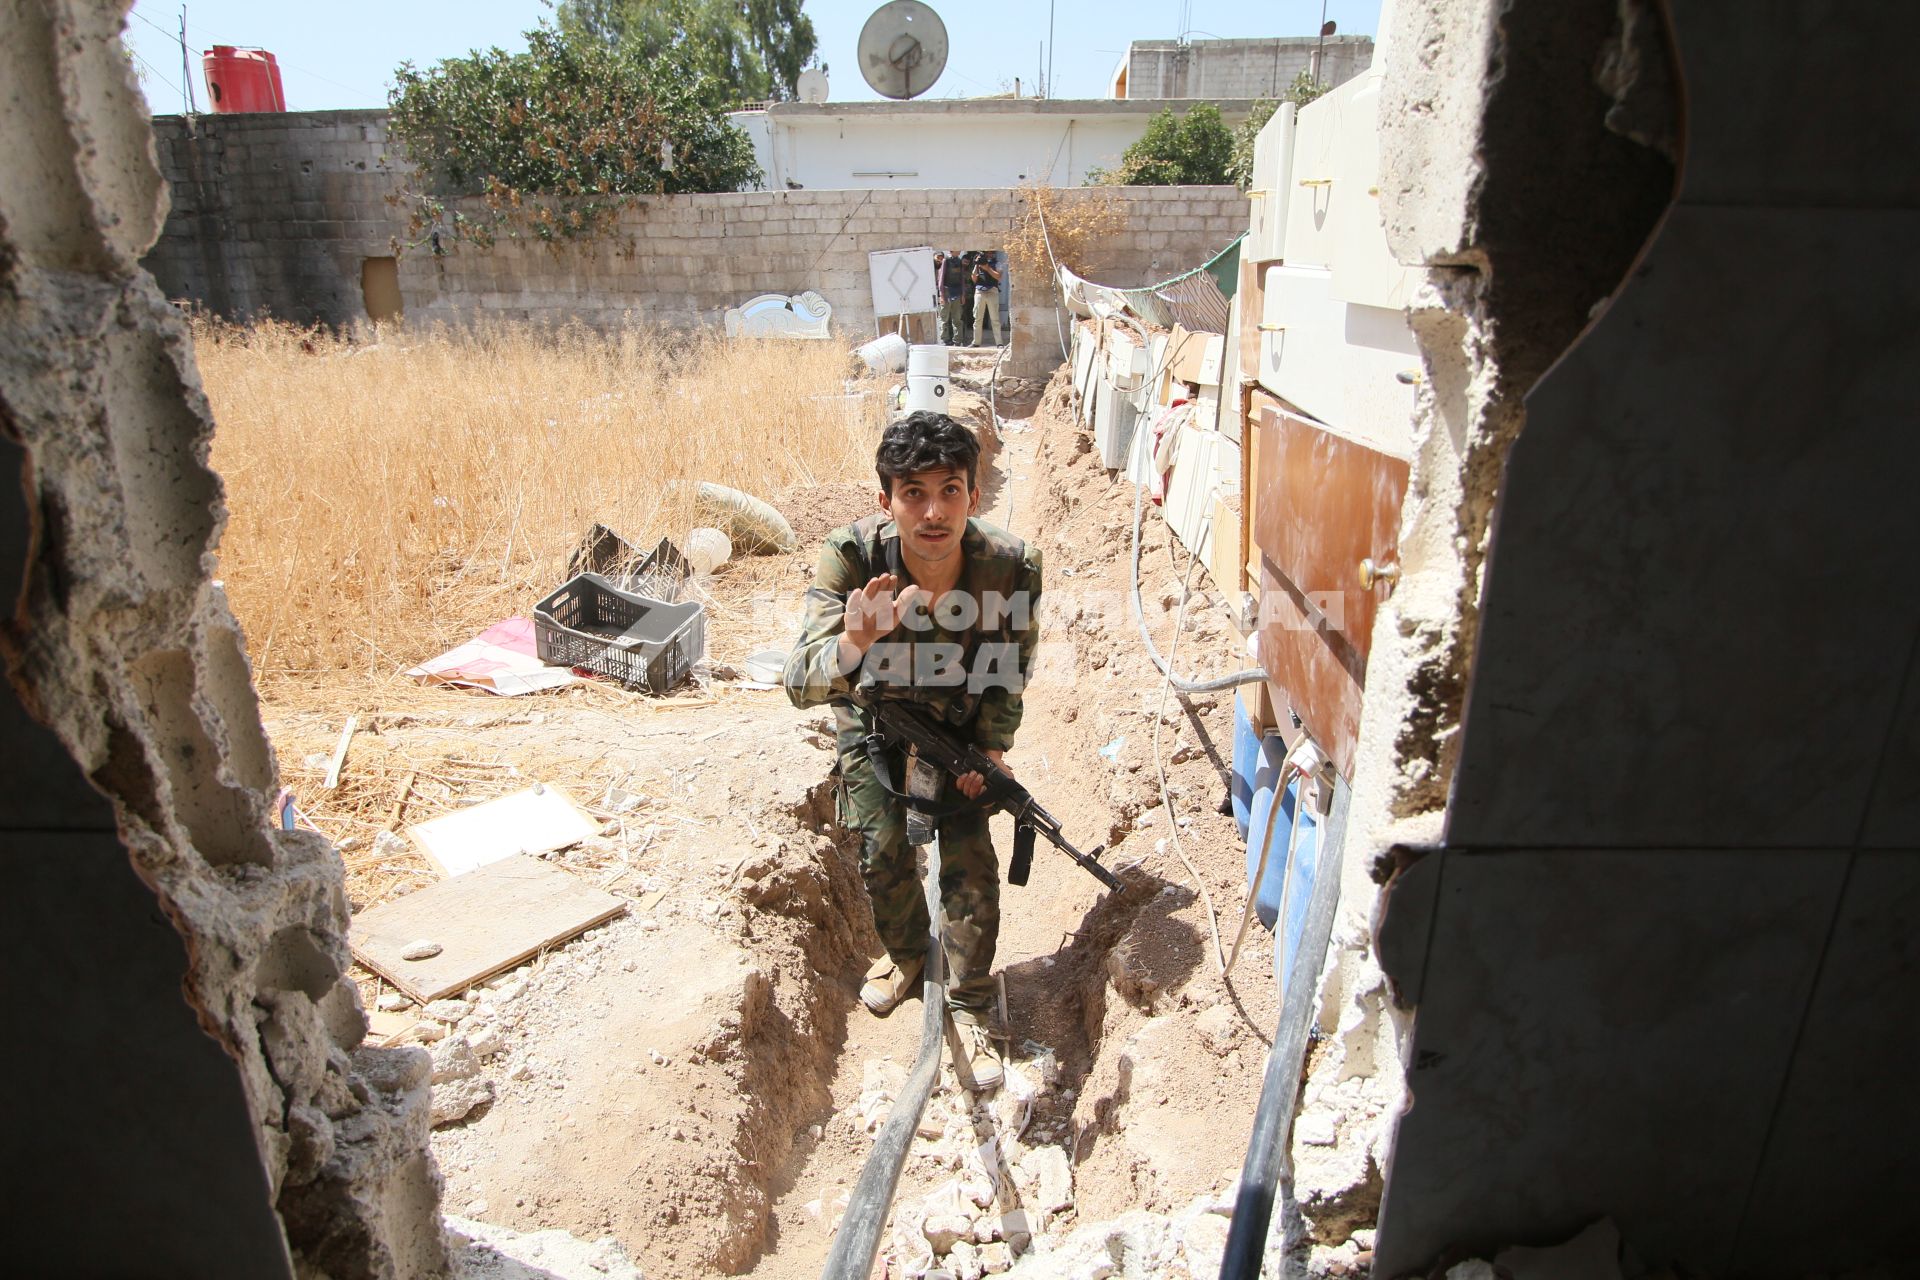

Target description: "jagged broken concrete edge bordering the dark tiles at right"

left=1294, top=0, right=1678, bottom=1244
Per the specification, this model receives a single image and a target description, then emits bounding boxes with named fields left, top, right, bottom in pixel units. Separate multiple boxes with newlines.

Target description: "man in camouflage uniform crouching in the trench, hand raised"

left=785, top=411, right=1041, bottom=1088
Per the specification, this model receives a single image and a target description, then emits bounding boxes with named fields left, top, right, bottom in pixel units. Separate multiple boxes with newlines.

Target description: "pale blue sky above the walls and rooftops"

left=127, top=0, right=1380, bottom=113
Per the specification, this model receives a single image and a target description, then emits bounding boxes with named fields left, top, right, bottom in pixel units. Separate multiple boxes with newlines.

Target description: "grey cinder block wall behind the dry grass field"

left=144, top=111, right=1248, bottom=376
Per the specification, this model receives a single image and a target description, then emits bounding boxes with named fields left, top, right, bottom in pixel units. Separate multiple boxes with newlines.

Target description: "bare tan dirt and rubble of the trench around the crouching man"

left=269, top=359, right=1277, bottom=1278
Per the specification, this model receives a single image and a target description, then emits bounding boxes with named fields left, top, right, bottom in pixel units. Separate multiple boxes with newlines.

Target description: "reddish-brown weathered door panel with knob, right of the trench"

left=1254, top=395, right=1407, bottom=777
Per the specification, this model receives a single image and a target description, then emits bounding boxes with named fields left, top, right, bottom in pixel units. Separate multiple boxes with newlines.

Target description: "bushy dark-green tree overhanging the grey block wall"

left=388, top=25, right=760, bottom=248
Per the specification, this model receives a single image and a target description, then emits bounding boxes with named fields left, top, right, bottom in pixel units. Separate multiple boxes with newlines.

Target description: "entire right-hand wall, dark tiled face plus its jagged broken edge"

left=1296, top=0, right=1920, bottom=1276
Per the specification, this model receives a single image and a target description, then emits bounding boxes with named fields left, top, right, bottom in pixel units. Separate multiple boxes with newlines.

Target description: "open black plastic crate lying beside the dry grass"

left=534, top=574, right=707, bottom=693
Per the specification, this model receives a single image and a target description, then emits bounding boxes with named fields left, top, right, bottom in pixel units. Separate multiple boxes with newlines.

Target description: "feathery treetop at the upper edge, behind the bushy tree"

left=549, top=0, right=816, bottom=106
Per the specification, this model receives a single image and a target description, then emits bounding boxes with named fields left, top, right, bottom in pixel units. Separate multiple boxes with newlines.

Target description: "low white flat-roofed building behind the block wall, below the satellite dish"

left=728, top=98, right=1252, bottom=190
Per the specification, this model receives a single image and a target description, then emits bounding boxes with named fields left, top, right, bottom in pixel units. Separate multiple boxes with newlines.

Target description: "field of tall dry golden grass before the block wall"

left=196, top=324, right=879, bottom=697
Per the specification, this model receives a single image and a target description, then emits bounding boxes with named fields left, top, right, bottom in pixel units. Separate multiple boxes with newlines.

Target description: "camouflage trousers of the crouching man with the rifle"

left=841, top=754, right=1000, bottom=1013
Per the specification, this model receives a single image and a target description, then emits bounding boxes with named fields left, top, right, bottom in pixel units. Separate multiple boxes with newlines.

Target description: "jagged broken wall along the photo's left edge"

left=0, top=0, right=447, bottom=1280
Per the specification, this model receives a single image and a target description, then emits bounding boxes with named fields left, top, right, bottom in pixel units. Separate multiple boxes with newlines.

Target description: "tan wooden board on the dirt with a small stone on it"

left=349, top=854, right=626, bottom=1004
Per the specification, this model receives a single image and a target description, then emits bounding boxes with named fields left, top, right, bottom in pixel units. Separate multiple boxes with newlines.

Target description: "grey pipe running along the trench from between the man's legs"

left=820, top=839, right=947, bottom=1280
